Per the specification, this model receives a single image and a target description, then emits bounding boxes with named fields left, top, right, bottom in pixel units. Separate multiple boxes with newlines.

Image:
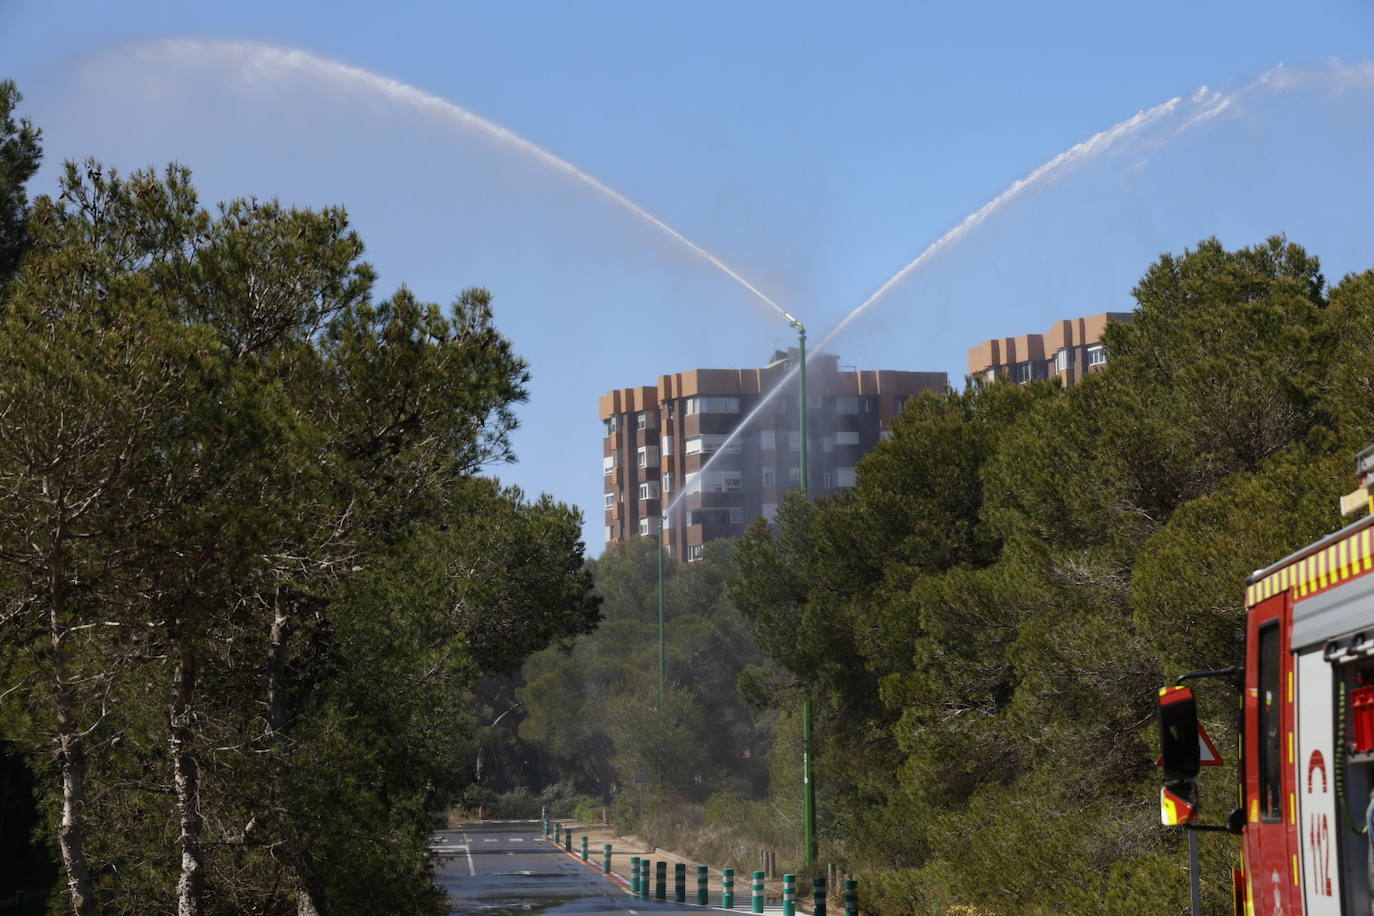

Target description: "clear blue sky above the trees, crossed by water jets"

left=0, top=0, right=1374, bottom=553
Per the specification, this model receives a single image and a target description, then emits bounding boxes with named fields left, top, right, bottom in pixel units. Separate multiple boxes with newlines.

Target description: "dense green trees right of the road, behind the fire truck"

left=500, top=238, right=1374, bottom=916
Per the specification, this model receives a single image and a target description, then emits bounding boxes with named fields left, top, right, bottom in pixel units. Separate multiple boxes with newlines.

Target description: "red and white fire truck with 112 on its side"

left=1160, top=446, right=1374, bottom=916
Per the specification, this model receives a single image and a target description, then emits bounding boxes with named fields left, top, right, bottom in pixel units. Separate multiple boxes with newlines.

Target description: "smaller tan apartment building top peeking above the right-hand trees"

left=969, top=312, right=1131, bottom=387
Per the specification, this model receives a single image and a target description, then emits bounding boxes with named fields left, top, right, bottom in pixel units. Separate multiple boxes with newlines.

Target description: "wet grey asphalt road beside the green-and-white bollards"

left=430, top=821, right=709, bottom=916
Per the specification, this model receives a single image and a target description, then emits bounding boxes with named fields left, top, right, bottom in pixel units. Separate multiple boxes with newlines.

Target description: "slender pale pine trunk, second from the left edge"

left=168, top=622, right=205, bottom=916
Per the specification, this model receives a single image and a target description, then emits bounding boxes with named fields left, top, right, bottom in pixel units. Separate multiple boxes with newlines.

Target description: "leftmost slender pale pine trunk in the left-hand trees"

left=48, top=555, right=100, bottom=916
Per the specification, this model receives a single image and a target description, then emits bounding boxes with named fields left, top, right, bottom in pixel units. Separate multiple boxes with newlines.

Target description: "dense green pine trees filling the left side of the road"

left=0, top=84, right=598, bottom=916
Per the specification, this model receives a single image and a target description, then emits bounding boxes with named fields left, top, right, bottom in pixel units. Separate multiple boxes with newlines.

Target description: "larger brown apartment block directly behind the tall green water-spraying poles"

left=600, top=349, right=948, bottom=560
